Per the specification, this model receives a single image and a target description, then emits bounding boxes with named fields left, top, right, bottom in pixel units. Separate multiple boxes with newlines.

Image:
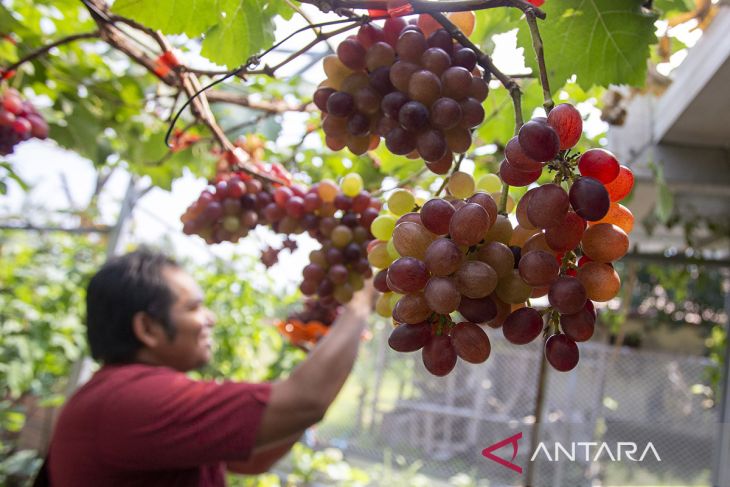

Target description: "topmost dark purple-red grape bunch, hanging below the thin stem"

left=314, top=12, right=489, bottom=174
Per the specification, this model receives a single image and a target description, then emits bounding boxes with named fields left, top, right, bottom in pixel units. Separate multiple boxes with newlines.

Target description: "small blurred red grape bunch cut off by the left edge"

left=0, top=88, right=48, bottom=156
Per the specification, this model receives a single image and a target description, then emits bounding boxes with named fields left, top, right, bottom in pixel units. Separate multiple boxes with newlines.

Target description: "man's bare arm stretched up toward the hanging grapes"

left=255, top=287, right=372, bottom=447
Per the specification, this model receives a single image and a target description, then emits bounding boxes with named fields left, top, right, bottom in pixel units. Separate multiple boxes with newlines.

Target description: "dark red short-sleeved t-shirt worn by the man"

left=49, top=364, right=271, bottom=487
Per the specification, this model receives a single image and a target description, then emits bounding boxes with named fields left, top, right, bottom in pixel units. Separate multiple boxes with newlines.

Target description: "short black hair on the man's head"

left=86, top=248, right=179, bottom=364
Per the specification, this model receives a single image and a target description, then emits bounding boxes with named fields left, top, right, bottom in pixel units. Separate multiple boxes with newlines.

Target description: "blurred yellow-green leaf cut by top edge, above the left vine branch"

left=112, top=0, right=222, bottom=37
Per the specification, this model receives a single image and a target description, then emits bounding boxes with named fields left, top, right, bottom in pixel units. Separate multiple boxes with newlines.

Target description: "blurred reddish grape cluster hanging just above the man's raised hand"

left=181, top=173, right=381, bottom=308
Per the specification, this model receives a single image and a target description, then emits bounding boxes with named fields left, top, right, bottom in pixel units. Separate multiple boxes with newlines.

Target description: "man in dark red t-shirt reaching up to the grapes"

left=48, top=250, right=370, bottom=487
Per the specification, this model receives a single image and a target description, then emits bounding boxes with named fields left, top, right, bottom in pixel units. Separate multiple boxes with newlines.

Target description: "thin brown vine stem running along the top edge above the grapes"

left=292, top=0, right=546, bottom=19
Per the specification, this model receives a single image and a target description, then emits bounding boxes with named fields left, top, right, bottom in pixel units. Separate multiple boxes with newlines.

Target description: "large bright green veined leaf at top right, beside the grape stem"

left=518, top=0, right=657, bottom=90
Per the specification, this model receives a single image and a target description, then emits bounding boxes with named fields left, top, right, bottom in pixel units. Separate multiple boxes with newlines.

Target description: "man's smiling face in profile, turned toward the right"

left=156, top=267, right=215, bottom=372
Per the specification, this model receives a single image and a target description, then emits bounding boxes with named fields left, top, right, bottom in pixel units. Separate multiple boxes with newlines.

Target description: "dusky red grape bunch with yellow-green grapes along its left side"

left=368, top=179, right=504, bottom=376
